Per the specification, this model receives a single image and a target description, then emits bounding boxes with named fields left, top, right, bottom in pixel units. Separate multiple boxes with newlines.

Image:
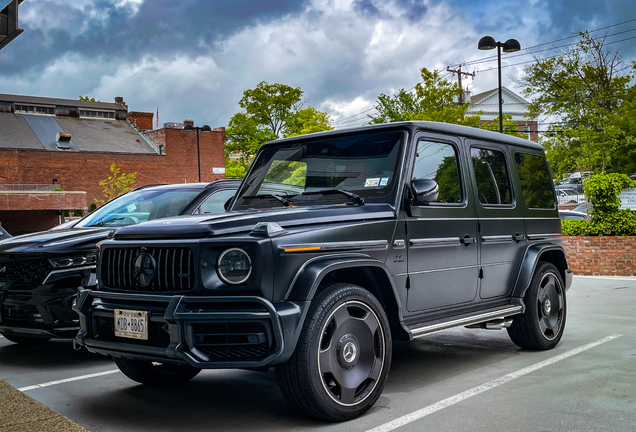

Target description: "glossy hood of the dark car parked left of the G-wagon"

left=0, top=227, right=113, bottom=253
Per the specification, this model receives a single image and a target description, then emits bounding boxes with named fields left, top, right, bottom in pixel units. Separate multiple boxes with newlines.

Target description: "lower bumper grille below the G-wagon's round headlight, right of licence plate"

left=192, top=322, right=270, bottom=361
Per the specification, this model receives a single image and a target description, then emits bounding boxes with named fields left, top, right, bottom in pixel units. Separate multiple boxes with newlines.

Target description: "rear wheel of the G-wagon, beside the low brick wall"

left=508, top=262, right=567, bottom=350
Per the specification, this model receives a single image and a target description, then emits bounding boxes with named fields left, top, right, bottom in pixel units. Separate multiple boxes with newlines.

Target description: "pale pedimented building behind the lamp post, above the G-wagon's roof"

left=466, top=87, right=539, bottom=142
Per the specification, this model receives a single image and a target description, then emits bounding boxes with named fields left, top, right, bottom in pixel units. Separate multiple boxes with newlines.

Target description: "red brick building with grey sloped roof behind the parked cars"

left=0, top=94, right=225, bottom=233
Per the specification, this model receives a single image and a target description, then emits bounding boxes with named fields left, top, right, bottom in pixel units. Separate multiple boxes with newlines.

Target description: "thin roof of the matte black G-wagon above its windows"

left=265, top=121, right=544, bottom=150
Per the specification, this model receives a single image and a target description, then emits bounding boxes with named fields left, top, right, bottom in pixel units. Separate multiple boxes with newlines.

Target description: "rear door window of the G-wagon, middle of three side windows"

left=470, top=147, right=512, bottom=205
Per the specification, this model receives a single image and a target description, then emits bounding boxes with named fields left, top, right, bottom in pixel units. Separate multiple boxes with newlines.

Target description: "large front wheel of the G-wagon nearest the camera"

left=276, top=283, right=392, bottom=421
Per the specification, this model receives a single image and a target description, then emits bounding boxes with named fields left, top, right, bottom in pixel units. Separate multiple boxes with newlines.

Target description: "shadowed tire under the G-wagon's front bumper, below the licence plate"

left=113, top=357, right=201, bottom=387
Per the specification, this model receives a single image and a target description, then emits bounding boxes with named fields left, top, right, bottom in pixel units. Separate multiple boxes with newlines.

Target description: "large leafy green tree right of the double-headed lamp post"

left=517, top=32, right=636, bottom=176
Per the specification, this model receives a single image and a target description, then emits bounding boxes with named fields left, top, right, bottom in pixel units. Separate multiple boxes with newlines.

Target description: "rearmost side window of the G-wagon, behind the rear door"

left=515, top=153, right=554, bottom=209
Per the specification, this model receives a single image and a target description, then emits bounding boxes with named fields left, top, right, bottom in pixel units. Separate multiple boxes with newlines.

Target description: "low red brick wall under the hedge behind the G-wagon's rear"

left=563, top=236, right=636, bottom=276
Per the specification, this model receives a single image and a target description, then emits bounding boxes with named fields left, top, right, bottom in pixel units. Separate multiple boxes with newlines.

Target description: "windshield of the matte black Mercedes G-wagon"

left=233, top=130, right=406, bottom=210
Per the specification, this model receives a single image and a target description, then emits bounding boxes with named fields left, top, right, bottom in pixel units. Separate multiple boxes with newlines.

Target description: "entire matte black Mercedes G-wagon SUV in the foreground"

left=75, top=122, right=572, bottom=420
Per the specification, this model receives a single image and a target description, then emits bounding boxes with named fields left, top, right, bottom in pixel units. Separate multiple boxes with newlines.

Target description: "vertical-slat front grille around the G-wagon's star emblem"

left=101, top=248, right=195, bottom=291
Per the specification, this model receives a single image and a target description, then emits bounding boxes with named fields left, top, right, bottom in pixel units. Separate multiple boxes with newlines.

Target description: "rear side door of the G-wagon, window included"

left=467, top=140, right=527, bottom=299
